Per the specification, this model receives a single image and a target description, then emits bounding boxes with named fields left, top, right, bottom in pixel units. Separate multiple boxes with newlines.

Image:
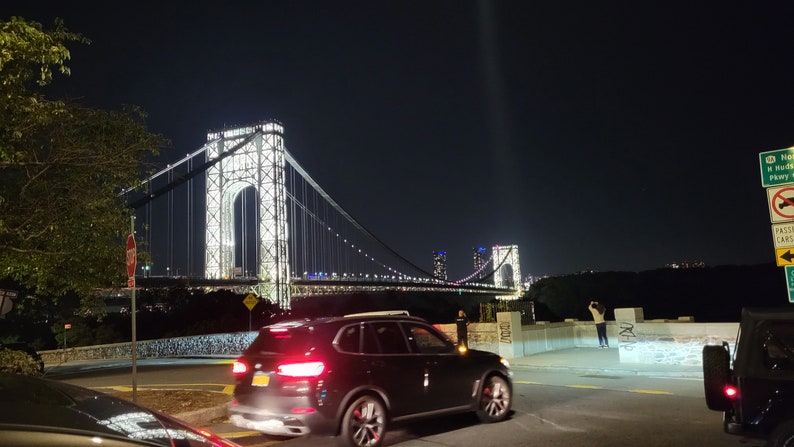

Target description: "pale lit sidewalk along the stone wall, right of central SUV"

left=509, top=347, right=703, bottom=378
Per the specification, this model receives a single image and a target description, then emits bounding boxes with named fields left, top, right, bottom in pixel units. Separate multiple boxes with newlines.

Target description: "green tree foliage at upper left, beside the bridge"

left=0, top=17, right=167, bottom=304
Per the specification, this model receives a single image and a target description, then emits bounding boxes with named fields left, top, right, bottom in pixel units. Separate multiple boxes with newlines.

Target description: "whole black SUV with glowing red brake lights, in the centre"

left=229, top=314, right=512, bottom=447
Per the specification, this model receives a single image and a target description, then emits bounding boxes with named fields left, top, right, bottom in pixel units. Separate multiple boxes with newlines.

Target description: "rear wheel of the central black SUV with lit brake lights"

left=340, top=395, right=386, bottom=447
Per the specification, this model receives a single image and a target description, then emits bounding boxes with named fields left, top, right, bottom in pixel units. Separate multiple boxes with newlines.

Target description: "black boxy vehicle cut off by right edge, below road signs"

left=703, top=307, right=794, bottom=447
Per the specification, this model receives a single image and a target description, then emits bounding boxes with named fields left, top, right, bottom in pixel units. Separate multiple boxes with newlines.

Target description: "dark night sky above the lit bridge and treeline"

left=6, top=0, right=794, bottom=279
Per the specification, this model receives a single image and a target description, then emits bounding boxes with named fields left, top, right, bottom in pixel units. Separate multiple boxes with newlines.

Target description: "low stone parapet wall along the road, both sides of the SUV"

left=39, top=313, right=739, bottom=365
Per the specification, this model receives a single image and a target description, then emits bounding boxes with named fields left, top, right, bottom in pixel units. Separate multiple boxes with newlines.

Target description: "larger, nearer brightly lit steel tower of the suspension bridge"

left=204, top=122, right=290, bottom=309
